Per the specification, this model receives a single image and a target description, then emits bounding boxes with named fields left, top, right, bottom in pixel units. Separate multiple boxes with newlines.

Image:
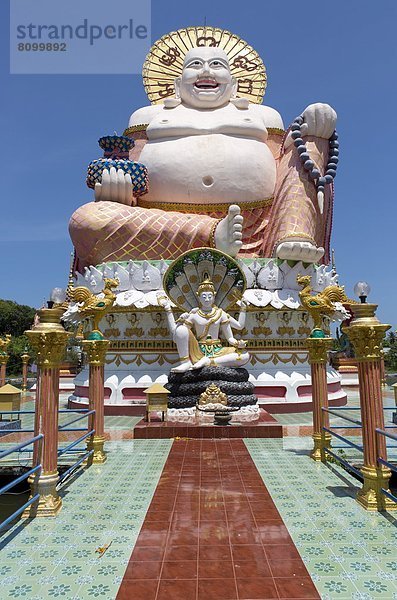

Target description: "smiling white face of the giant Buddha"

left=175, top=47, right=236, bottom=109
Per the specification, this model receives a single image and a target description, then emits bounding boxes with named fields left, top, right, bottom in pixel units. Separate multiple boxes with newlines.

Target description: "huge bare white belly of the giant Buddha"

left=139, top=134, right=276, bottom=204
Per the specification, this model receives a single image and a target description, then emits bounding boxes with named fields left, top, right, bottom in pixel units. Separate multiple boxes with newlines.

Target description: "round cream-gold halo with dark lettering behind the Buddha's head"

left=142, top=26, right=267, bottom=104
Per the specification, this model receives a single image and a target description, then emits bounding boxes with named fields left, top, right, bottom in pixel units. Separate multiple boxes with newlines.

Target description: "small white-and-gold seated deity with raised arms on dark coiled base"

left=158, top=279, right=250, bottom=373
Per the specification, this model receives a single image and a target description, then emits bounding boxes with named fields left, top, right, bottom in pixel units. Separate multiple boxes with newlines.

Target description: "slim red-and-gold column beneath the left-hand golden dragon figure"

left=82, top=339, right=110, bottom=464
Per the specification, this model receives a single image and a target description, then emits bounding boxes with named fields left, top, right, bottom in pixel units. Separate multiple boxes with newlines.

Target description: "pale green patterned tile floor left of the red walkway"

left=0, top=440, right=172, bottom=600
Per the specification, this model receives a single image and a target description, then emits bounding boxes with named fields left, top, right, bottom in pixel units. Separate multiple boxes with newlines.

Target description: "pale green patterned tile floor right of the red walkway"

left=245, top=438, right=397, bottom=600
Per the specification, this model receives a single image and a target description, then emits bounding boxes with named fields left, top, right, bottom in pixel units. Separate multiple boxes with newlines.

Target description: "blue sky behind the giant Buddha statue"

left=0, top=0, right=397, bottom=327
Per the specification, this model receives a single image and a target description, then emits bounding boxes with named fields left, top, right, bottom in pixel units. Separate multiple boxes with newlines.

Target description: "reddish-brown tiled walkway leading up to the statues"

left=117, top=440, right=320, bottom=600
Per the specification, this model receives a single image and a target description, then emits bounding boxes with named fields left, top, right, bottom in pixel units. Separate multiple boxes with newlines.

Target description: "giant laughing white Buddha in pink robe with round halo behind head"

left=70, top=28, right=336, bottom=270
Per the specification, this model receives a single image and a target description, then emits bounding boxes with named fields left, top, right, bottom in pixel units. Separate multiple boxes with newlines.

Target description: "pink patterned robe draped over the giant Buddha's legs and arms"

left=69, top=130, right=333, bottom=270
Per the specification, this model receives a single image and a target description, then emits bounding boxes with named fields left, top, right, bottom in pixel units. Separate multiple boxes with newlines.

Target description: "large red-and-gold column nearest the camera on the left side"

left=24, top=307, right=70, bottom=517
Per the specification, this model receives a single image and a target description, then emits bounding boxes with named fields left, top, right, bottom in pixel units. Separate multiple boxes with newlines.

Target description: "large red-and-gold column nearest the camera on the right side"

left=344, top=303, right=397, bottom=511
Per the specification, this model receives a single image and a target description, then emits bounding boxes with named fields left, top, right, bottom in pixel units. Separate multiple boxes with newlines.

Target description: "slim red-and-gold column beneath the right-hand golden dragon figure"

left=306, top=337, right=333, bottom=462
